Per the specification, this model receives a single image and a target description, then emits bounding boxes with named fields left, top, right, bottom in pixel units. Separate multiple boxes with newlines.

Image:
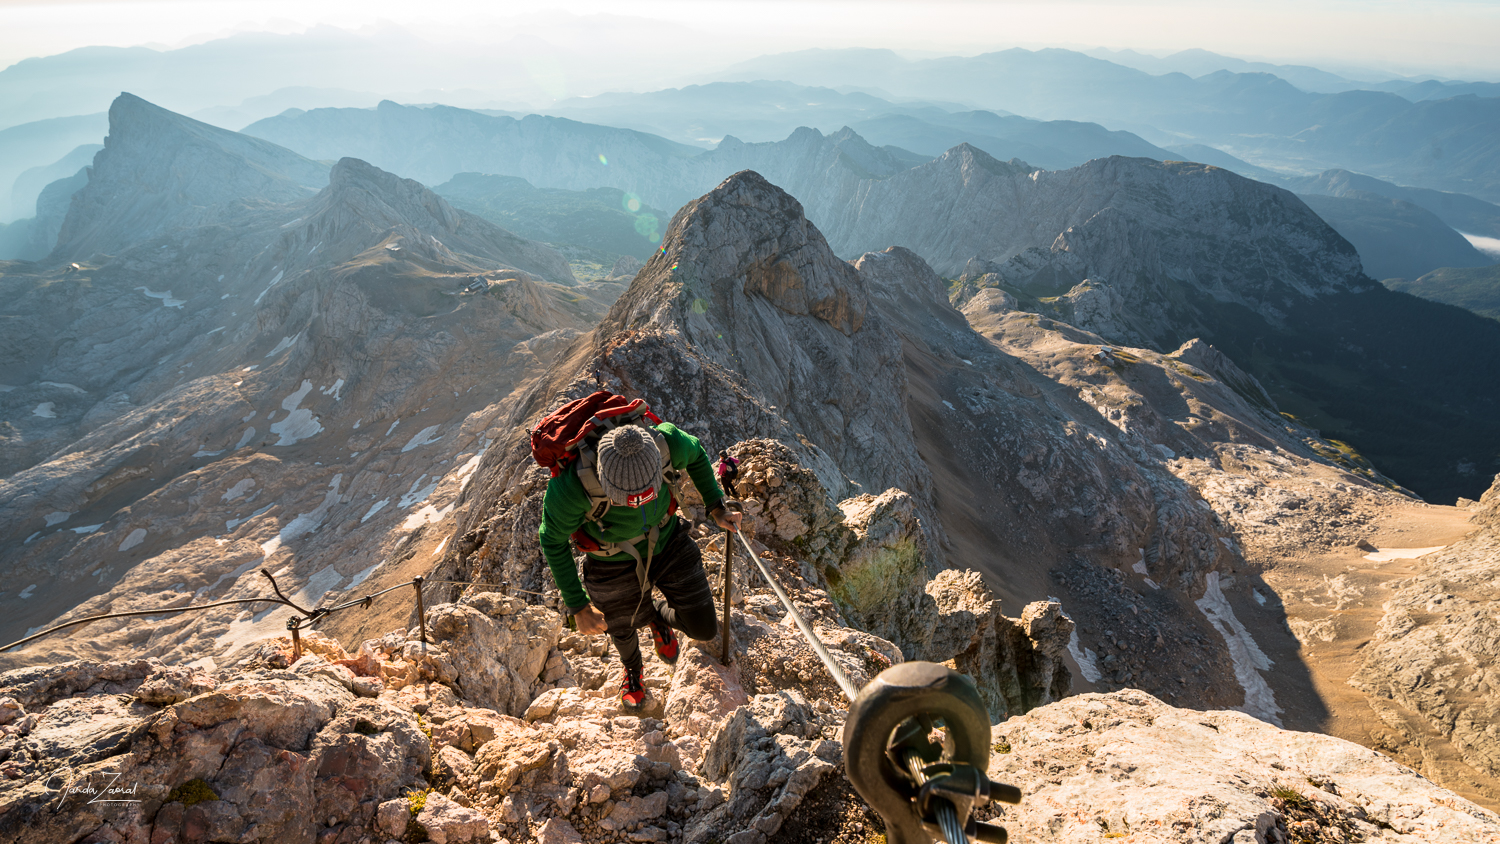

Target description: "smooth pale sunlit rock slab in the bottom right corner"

left=990, top=691, right=1500, bottom=844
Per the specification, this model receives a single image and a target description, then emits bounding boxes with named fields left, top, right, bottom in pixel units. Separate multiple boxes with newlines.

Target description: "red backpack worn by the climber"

left=531, top=390, right=678, bottom=552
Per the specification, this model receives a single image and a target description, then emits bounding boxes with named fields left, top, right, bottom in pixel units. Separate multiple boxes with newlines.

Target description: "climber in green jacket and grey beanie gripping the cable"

left=539, top=423, right=741, bottom=709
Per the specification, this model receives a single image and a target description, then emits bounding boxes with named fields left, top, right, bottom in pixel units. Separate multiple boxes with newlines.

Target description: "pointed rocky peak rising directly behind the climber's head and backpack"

left=456, top=172, right=932, bottom=528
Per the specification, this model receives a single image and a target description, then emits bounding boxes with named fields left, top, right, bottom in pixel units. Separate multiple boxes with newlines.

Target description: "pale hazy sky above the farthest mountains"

left=0, top=0, right=1500, bottom=81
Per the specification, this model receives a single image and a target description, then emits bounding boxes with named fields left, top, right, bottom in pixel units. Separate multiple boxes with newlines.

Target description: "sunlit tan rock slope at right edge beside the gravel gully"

left=1349, top=475, right=1500, bottom=796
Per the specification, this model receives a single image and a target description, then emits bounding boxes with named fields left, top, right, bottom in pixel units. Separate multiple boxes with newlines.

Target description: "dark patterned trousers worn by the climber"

left=584, top=523, right=719, bottom=669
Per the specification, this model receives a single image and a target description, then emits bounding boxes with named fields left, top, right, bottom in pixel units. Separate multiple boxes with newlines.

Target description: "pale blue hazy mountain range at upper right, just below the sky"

left=714, top=49, right=1500, bottom=201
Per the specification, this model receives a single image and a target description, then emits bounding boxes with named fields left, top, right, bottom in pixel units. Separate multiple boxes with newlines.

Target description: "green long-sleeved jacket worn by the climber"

left=537, top=423, right=725, bottom=612
